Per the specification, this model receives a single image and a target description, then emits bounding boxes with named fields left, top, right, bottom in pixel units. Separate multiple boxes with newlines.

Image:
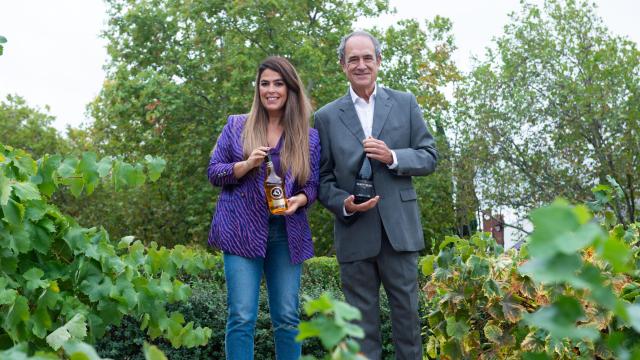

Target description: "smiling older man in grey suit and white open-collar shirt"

left=315, top=31, right=438, bottom=360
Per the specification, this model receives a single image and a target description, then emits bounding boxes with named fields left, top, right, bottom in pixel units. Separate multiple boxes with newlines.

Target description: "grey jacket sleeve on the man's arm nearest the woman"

left=314, top=113, right=358, bottom=223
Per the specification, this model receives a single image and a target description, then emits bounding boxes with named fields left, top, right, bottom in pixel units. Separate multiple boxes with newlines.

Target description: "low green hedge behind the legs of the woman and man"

left=96, top=257, right=422, bottom=360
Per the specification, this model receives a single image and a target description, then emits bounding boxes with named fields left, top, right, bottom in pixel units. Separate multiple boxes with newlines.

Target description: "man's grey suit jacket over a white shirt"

left=315, top=86, right=438, bottom=262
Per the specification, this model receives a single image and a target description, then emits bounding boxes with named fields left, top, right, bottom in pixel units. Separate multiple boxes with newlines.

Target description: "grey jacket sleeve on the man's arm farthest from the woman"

left=392, top=94, right=438, bottom=176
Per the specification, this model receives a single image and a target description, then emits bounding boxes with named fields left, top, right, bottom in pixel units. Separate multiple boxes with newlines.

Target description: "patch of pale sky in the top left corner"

left=0, top=0, right=107, bottom=130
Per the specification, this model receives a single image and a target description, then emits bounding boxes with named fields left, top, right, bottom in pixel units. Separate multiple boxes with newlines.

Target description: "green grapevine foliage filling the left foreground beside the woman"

left=0, top=145, right=212, bottom=355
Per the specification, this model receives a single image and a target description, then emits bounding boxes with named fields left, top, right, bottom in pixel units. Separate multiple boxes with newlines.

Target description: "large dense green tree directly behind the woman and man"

left=77, top=0, right=464, bottom=254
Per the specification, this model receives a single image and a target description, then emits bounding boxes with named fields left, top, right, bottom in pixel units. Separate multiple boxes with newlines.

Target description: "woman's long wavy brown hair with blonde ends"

left=242, top=56, right=312, bottom=185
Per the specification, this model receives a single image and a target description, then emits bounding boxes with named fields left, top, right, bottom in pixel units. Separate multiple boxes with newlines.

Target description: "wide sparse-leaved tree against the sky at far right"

left=452, top=0, right=640, bottom=229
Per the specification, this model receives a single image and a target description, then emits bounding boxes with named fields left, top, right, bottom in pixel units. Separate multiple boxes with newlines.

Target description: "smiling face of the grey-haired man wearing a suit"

left=341, top=35, right=381, bottom=91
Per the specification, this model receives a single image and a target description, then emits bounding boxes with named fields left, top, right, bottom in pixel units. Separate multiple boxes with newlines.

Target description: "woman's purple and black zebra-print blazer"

left=208, top=115, right=320, bottom=264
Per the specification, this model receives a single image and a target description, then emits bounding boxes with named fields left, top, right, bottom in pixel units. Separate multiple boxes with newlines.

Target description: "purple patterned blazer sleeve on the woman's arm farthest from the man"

left=207, top=116, right=240, bottom=186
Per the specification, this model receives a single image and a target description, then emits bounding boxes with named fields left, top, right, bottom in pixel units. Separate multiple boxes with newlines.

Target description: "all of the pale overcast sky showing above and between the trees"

left=0, top=0, right=640, bottom=131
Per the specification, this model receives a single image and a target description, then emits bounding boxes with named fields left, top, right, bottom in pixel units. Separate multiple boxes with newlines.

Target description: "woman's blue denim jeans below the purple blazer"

left=224, top=216, right=302, bottom=360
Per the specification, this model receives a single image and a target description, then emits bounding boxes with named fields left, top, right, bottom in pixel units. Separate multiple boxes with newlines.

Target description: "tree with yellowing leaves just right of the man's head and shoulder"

left=380, top=16, right=473, bottom=248
